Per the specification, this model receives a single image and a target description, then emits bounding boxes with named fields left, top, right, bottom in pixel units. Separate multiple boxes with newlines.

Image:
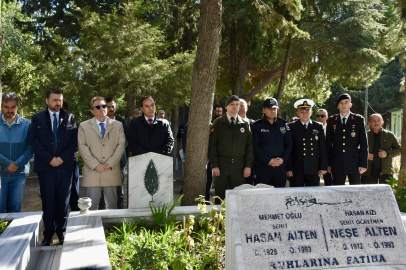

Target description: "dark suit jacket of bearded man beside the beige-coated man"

left=30, top=108, right=78, bottom=173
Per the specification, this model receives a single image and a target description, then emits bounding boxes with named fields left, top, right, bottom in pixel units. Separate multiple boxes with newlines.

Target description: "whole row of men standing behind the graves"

left=0, top=88, right=400, bottom=246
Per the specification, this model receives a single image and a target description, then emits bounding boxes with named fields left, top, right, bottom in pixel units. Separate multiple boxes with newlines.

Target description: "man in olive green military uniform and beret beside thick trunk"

left=209, top=95, right=254, bottom=199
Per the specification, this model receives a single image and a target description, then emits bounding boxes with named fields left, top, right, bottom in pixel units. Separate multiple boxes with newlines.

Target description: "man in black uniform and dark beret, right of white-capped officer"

left=327, top=94, right=368, bottom=185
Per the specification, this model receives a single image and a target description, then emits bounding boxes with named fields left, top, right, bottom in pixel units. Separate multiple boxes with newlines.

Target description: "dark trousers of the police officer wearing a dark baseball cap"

left=254, top=165, right=286, bottom=188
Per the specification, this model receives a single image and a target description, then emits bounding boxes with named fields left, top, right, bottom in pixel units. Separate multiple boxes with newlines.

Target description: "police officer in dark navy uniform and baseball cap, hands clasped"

left=252, top=98, right=292, bottom=187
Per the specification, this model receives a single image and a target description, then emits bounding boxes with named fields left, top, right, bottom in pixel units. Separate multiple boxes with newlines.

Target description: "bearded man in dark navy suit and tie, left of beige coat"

left=31, top=88, right=78, bottom=246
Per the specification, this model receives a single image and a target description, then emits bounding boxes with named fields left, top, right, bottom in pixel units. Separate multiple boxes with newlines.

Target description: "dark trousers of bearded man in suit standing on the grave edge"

left=38, top=169, right=72, bottom=239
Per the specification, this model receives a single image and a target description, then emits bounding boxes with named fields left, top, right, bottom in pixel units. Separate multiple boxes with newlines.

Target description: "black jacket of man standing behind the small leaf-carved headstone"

left=128, top=114, right=174, bottom=156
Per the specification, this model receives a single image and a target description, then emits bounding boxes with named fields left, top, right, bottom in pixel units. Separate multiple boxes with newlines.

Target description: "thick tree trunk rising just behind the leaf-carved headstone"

left=182, top=0, right=223, bottom=205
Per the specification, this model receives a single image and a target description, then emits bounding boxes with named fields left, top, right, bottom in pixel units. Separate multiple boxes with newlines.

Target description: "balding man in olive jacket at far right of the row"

left=361, top=113, right=400, bottom=184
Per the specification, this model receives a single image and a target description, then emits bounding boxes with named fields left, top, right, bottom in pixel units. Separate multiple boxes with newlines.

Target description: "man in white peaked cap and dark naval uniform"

left=287, top=99, right=327, bottom=187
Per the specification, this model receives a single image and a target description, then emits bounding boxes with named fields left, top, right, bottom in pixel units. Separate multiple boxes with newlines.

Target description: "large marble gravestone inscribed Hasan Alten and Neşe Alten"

left=226, top=185, right=406, bottom=270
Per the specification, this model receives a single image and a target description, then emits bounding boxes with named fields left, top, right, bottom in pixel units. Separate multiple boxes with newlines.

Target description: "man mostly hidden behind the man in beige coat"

left=105, top=98, right=128, bottom=209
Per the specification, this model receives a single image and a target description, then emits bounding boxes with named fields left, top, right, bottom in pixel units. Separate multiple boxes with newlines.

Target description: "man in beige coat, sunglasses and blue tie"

left=78, top=97, right=125, bottom=210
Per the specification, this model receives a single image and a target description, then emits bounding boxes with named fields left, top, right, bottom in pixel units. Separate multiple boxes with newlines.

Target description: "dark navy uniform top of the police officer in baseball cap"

left=252, top=117, right=292, bottom=166
